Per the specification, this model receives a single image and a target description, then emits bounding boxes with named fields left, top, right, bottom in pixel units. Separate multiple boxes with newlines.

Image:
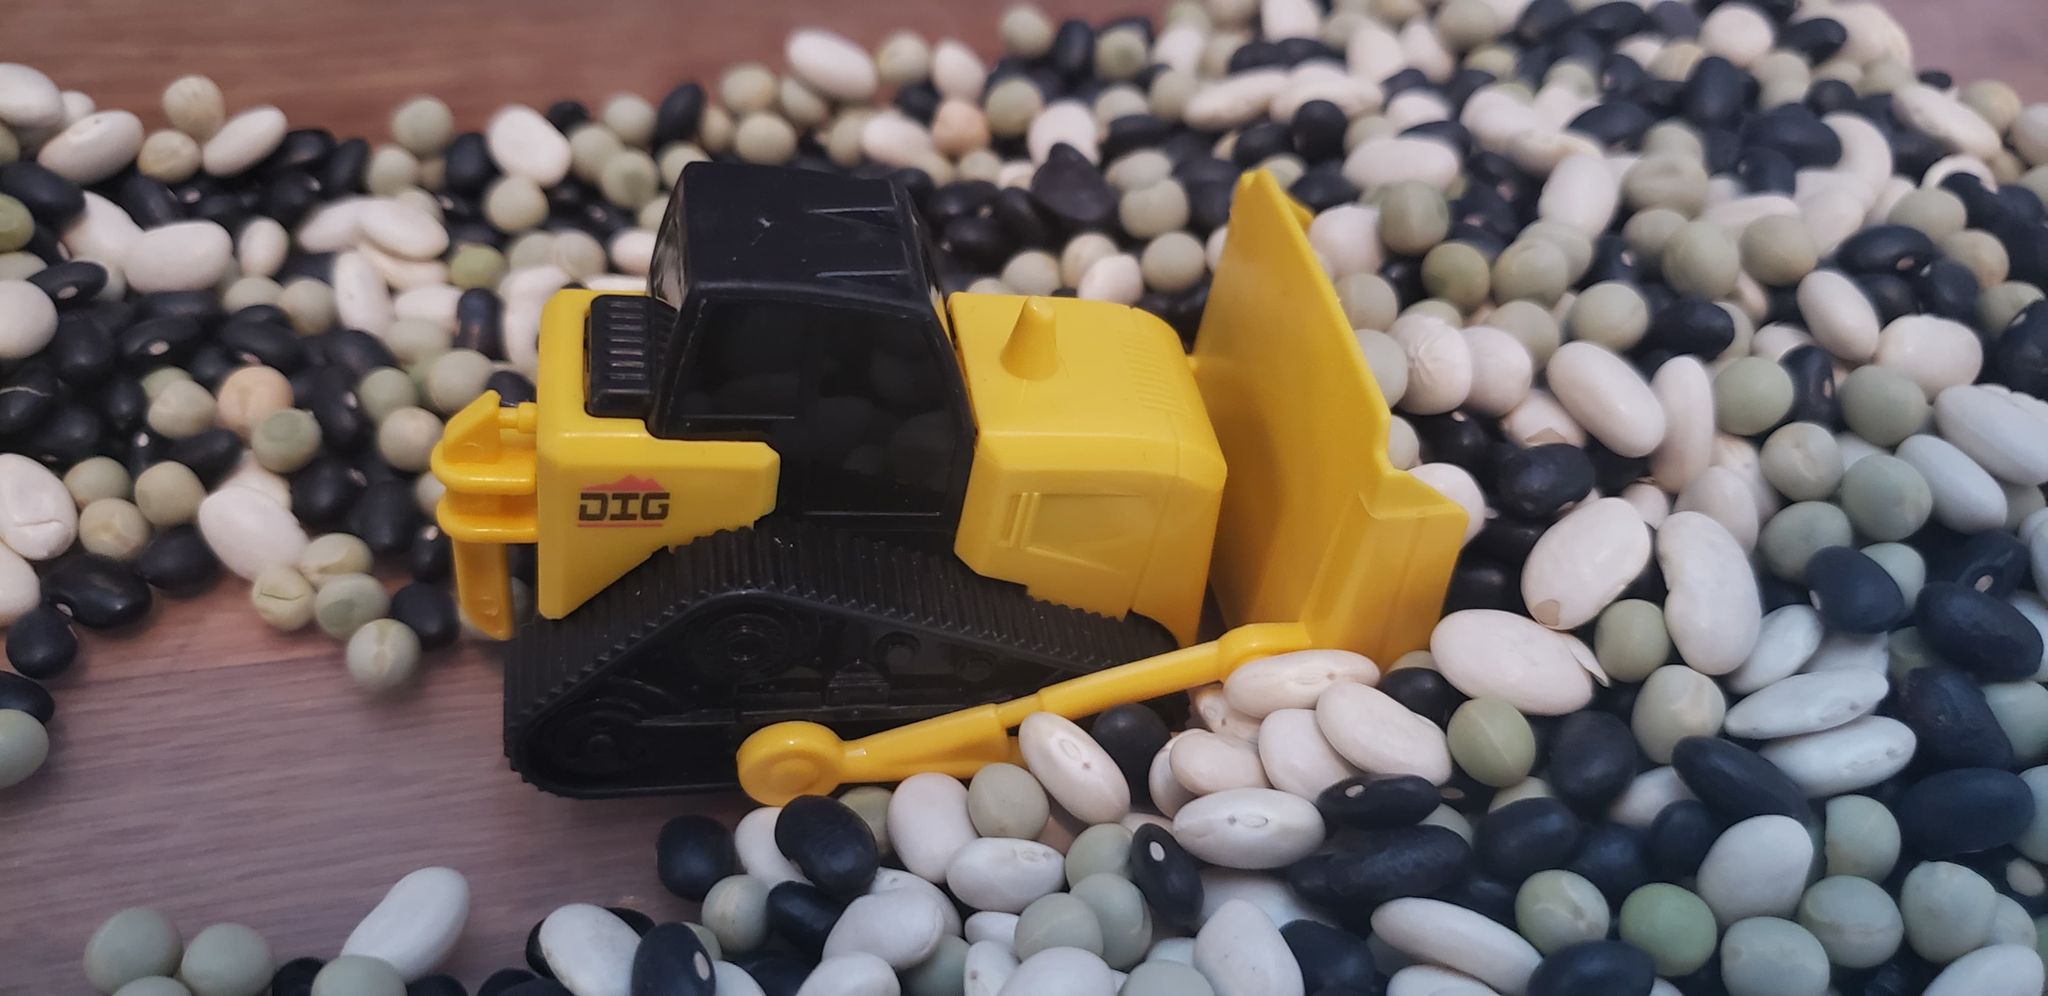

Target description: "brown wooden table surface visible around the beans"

left=0, top=0, right=2048, bottom=996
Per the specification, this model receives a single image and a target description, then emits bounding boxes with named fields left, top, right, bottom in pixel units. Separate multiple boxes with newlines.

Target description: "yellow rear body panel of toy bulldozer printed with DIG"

left=434, top=291, right=780, bottom=639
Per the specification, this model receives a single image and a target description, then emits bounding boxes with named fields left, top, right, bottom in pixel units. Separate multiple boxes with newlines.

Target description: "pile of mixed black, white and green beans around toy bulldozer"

left=19, top=0, right=2048, bottom=996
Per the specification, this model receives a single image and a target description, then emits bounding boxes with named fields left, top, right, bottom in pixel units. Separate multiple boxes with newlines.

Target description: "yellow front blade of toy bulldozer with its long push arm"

left=737, top=172, right=1464, bottom=805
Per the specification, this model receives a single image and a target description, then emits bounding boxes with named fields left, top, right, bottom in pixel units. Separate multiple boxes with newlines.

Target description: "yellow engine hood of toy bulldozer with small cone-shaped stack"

left=946, top=293, right=1225, bottom=644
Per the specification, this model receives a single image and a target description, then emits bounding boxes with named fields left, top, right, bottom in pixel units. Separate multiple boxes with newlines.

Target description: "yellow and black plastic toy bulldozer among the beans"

left=434, top=164, right=1464, bottom=803
